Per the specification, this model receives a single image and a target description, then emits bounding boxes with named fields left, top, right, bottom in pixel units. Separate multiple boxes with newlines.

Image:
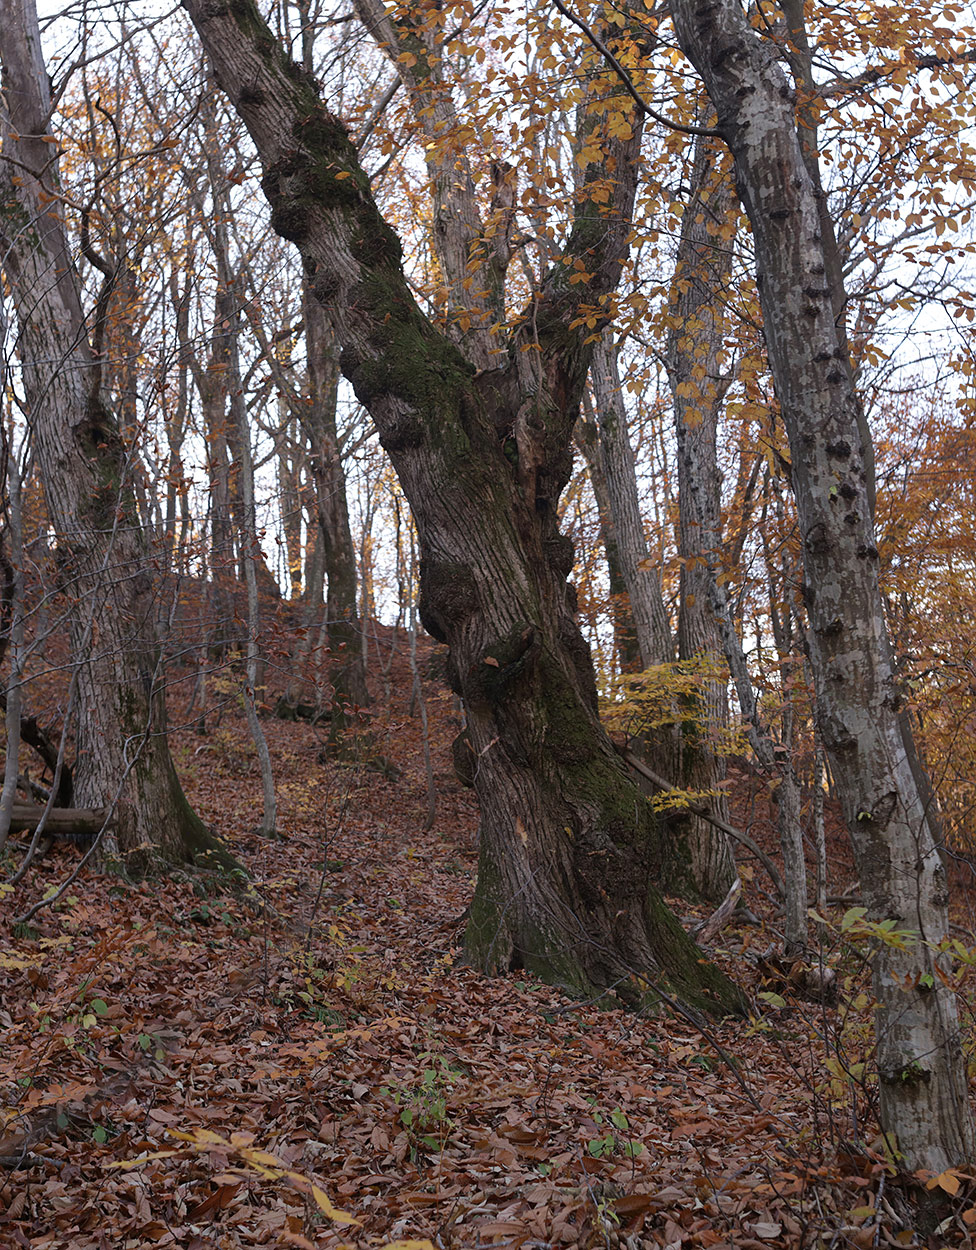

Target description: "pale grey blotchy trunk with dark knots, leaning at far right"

left=672, top=0, right=974, bottom=1173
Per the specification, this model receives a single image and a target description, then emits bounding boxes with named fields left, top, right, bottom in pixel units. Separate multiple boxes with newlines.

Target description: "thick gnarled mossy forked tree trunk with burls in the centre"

left=184, top=0, right=742, bottom=1010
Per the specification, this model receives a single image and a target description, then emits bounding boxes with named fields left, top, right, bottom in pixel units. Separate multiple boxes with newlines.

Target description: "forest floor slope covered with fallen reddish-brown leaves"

left=0, top=625, right=976, bottom=1250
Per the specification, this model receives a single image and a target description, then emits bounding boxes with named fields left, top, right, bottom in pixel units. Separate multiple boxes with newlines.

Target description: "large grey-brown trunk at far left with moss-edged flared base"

left=0, top=0, right=235, bottom=868
